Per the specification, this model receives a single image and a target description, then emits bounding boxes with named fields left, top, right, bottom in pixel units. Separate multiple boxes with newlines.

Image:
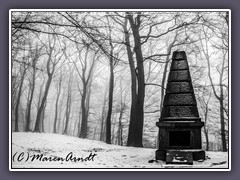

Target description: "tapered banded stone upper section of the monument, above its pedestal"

left=160, top=51, right=201, bottom=121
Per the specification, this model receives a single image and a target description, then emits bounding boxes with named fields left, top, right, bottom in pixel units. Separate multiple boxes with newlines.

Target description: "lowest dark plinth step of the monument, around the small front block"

left=156, top=149, right=206, bottom=161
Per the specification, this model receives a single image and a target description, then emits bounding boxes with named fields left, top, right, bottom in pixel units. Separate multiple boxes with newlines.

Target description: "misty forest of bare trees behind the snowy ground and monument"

left=9, top=11, right=230, bottom=152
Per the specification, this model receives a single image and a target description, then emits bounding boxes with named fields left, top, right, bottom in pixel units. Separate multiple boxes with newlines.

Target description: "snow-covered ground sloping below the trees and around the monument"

left=10, top=132, right=228, bottom=169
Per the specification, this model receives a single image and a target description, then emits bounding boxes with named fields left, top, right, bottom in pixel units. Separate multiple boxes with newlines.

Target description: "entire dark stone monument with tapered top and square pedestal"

left=156, top=51, right=205, bottom=164
